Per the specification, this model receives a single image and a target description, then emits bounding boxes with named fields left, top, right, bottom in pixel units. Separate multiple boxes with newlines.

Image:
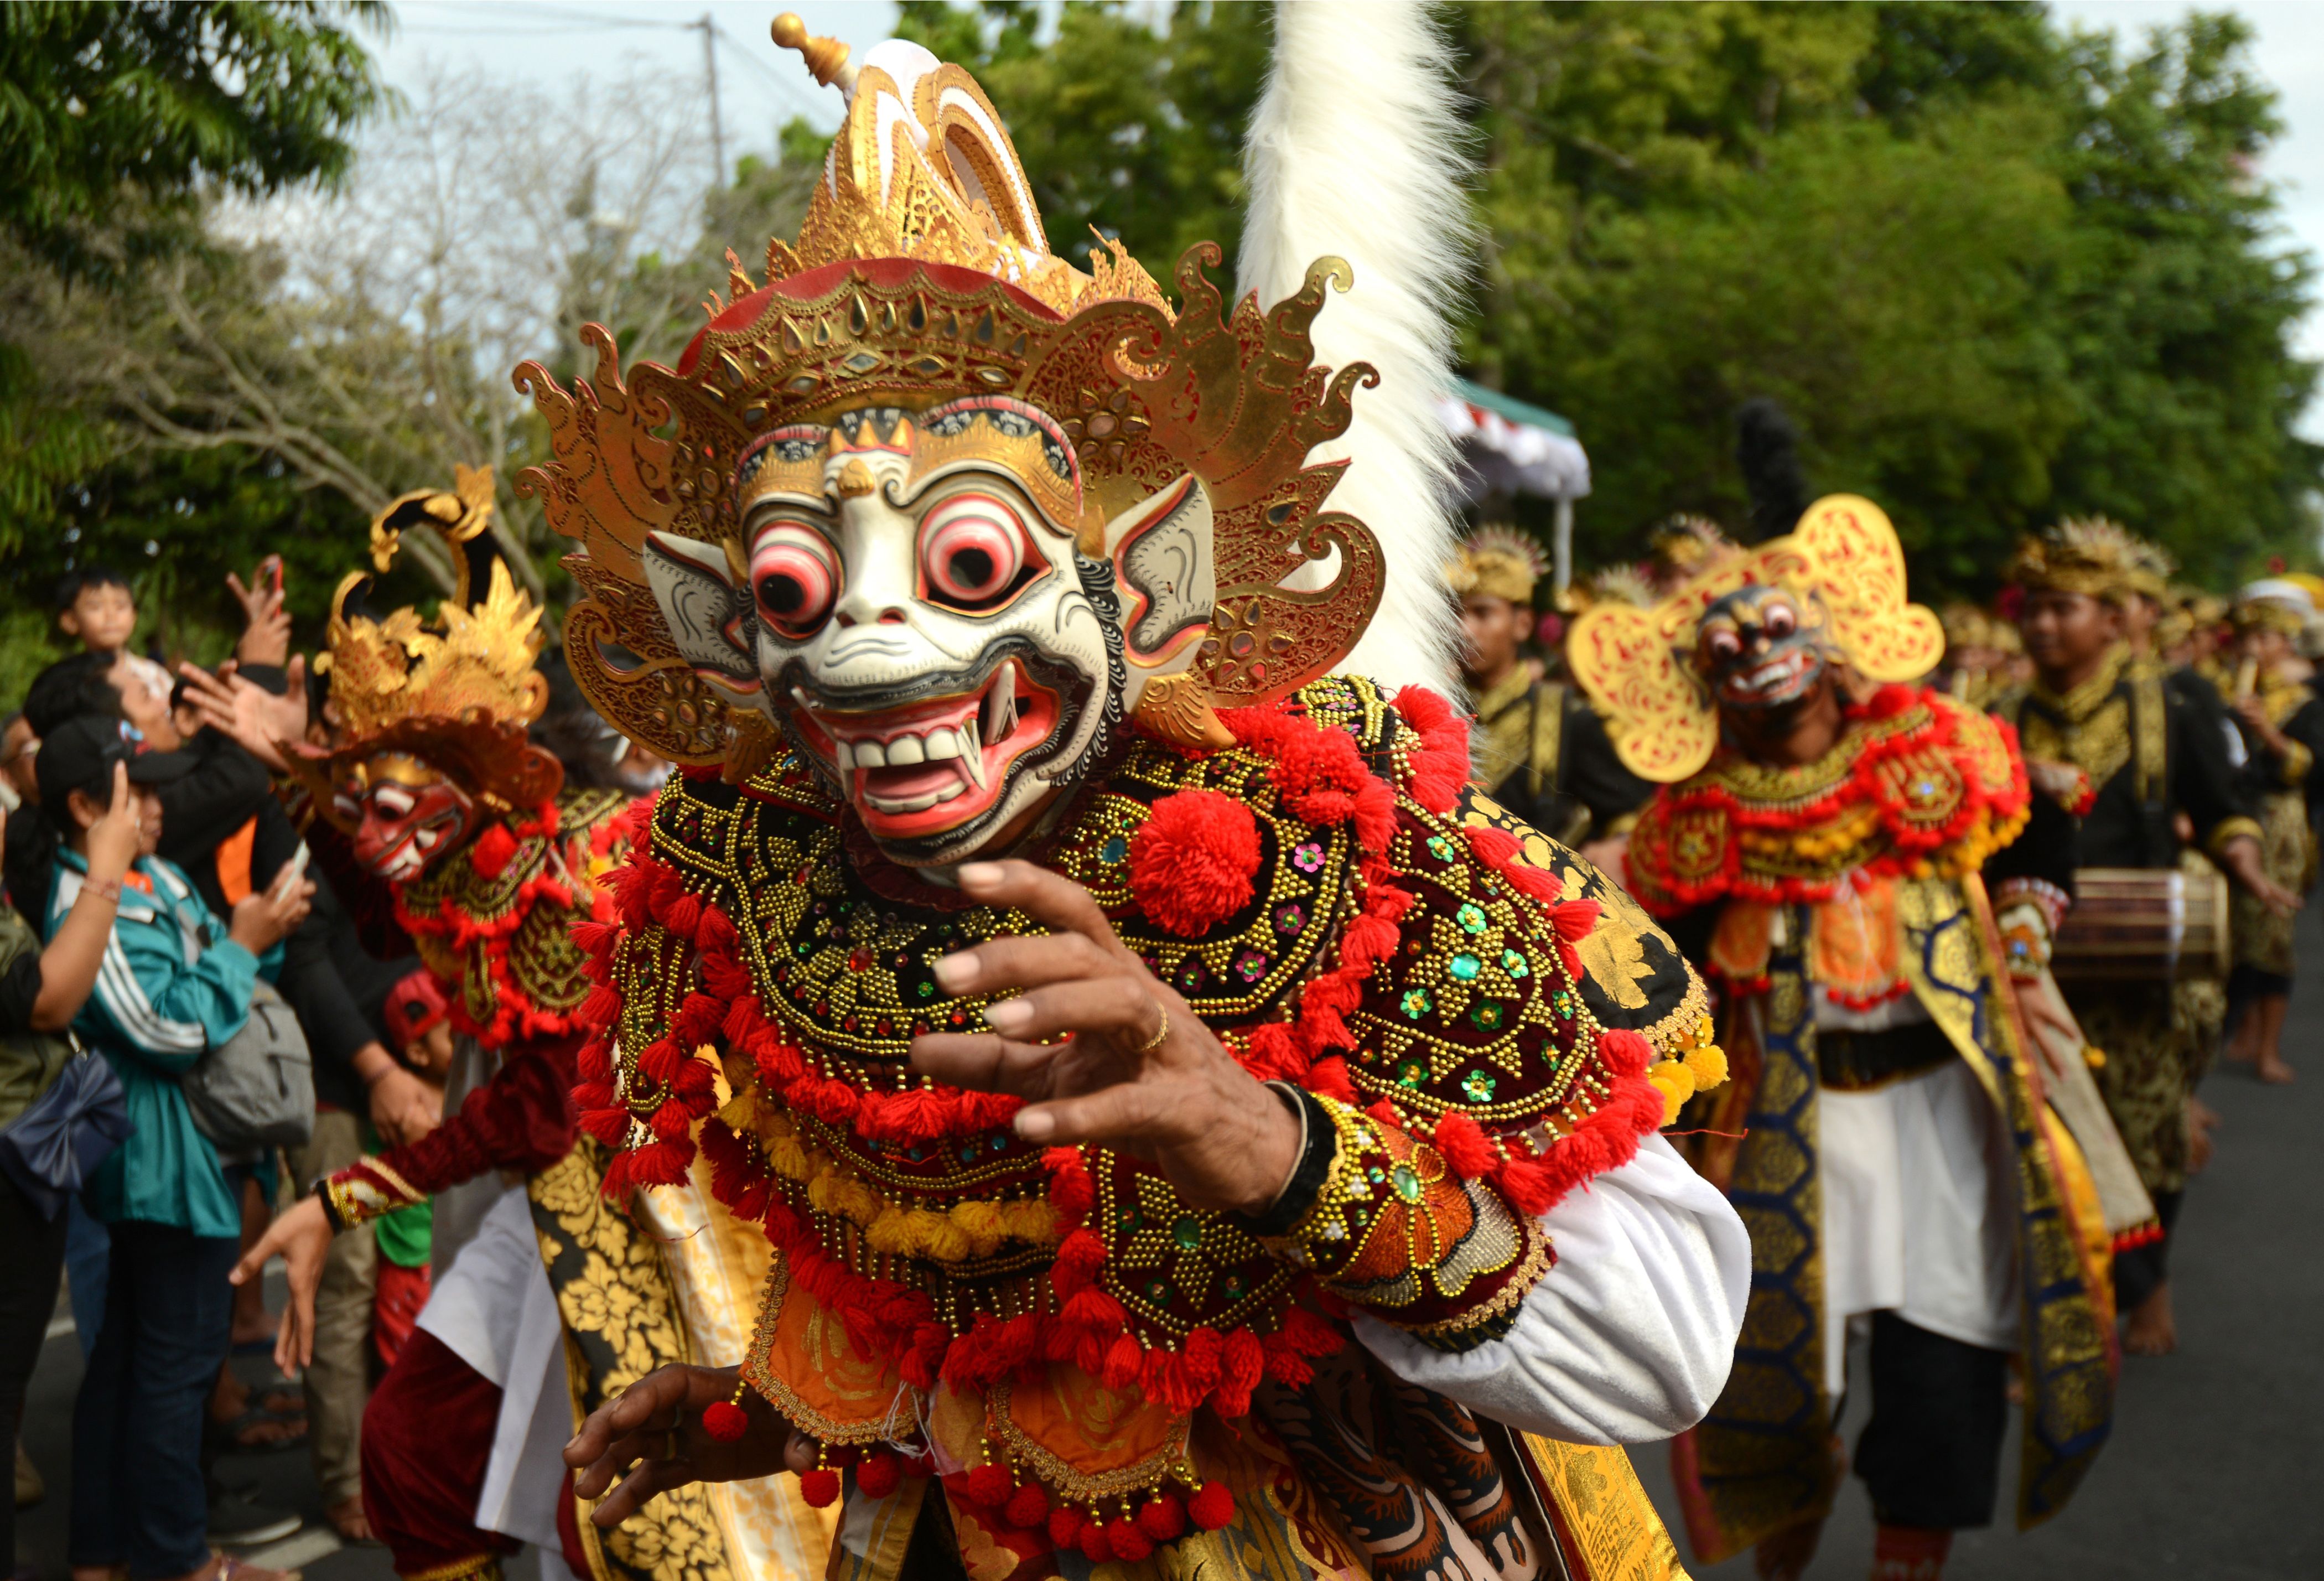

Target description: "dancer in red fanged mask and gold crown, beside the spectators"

left=240, top=470, right=825, bottom=1581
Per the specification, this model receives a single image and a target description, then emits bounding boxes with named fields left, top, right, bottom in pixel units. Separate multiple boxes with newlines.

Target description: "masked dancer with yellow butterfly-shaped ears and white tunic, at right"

left=1566, top=495, right=2113, bottom=1581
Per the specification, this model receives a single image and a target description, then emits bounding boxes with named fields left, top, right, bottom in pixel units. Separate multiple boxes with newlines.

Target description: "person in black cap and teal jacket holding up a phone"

left=37, top=716, right=314, bottom=1579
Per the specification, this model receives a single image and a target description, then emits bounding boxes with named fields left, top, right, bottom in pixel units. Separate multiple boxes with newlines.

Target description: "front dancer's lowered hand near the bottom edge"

left=565, top=1365, right=823, bottom=1530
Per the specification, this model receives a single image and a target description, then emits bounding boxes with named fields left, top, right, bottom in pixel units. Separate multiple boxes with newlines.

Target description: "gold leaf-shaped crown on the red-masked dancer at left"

left=281, top=467, right=565, bottom=830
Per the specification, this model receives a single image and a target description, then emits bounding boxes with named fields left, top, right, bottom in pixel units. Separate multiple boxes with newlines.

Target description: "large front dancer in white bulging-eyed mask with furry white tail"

left=523, top=7, right=1747, bottom=1581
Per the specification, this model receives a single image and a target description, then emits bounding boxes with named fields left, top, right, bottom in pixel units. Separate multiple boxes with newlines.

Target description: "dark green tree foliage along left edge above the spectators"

left=0, top=0, right=386, bottom=702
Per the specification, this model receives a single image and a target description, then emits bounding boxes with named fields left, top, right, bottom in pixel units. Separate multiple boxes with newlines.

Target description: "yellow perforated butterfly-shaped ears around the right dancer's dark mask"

left=1566, top=495, right=1945, bottom=784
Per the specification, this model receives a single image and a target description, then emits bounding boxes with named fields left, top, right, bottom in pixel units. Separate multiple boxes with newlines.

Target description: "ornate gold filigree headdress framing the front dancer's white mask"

left=516, top=16, right=1385, bottom=779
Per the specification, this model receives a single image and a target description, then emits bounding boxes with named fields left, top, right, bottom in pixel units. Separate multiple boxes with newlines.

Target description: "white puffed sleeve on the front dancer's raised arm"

left=1355, top=1137, right=1750, bottom=1444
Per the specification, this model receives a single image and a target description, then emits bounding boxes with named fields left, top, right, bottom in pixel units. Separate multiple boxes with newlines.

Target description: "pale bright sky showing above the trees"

left=381, top=0, right=2324, bottom=439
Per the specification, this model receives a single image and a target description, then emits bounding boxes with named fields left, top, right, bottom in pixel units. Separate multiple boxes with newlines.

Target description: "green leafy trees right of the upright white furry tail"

left=1462, top=4, right=2324, bottom=595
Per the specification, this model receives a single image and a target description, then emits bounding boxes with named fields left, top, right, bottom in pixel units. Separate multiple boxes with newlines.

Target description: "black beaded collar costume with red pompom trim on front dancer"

left=581, top=677, right=1704, bottom=1502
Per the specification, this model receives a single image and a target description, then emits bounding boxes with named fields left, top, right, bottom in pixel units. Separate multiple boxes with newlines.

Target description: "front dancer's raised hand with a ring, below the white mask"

left=911, top=863, right=1299, bottom=1214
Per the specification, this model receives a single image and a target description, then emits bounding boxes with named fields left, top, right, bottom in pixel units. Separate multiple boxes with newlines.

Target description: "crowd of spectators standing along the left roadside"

left=0, top=563, right=665, bottom=1581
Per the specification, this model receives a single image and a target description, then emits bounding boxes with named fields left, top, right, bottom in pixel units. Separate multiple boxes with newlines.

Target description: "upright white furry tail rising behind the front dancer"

left=1236, top=0, right=1474, bottom=697
